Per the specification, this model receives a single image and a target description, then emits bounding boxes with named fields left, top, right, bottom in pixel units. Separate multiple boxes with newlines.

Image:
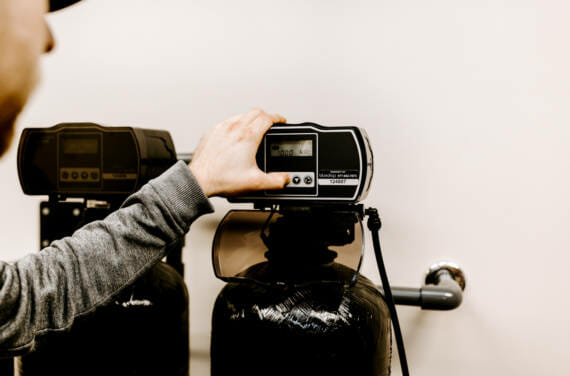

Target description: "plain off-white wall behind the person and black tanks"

left=0, top=0, right=570, bottom=375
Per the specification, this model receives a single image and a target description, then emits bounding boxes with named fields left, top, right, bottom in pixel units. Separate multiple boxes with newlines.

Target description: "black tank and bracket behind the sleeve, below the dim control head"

left=18, top=202, right=189, bottom=376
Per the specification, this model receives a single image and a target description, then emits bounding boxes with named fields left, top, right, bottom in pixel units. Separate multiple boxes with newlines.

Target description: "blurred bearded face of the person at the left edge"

left=0, top=0, right=54, bottom=156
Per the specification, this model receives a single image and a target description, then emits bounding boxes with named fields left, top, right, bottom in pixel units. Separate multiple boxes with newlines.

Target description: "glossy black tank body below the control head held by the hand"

left=211, top=264, right=391, bottom=376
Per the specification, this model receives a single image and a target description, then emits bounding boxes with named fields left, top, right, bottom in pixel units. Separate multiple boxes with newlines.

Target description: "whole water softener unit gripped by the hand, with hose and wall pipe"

left=211, top=123, right=465, bottom=376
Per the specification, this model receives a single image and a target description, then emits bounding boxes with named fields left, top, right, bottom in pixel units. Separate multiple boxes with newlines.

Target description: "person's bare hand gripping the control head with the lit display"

left=190, top=109, right=290, bottom=197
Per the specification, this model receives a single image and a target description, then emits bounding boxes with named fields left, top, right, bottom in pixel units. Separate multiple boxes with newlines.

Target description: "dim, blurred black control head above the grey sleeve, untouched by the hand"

left=18, top=123, right=177, bottom=198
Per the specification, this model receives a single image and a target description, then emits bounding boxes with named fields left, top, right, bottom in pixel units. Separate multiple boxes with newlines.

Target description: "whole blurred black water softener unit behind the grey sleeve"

left=18, top=123, right=189, bottom=376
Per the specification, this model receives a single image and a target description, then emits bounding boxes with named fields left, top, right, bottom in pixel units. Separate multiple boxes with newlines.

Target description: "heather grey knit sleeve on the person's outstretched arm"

left=0, top=162, right=213, bottom=356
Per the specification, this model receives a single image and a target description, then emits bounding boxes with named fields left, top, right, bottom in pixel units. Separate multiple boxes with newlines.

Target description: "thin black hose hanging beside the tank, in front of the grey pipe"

left=366, top=208, right=410, bottom=376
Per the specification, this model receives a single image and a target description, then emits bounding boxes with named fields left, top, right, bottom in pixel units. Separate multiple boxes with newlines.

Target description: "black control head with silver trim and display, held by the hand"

left=229, top=123, right=374, bottom=206
